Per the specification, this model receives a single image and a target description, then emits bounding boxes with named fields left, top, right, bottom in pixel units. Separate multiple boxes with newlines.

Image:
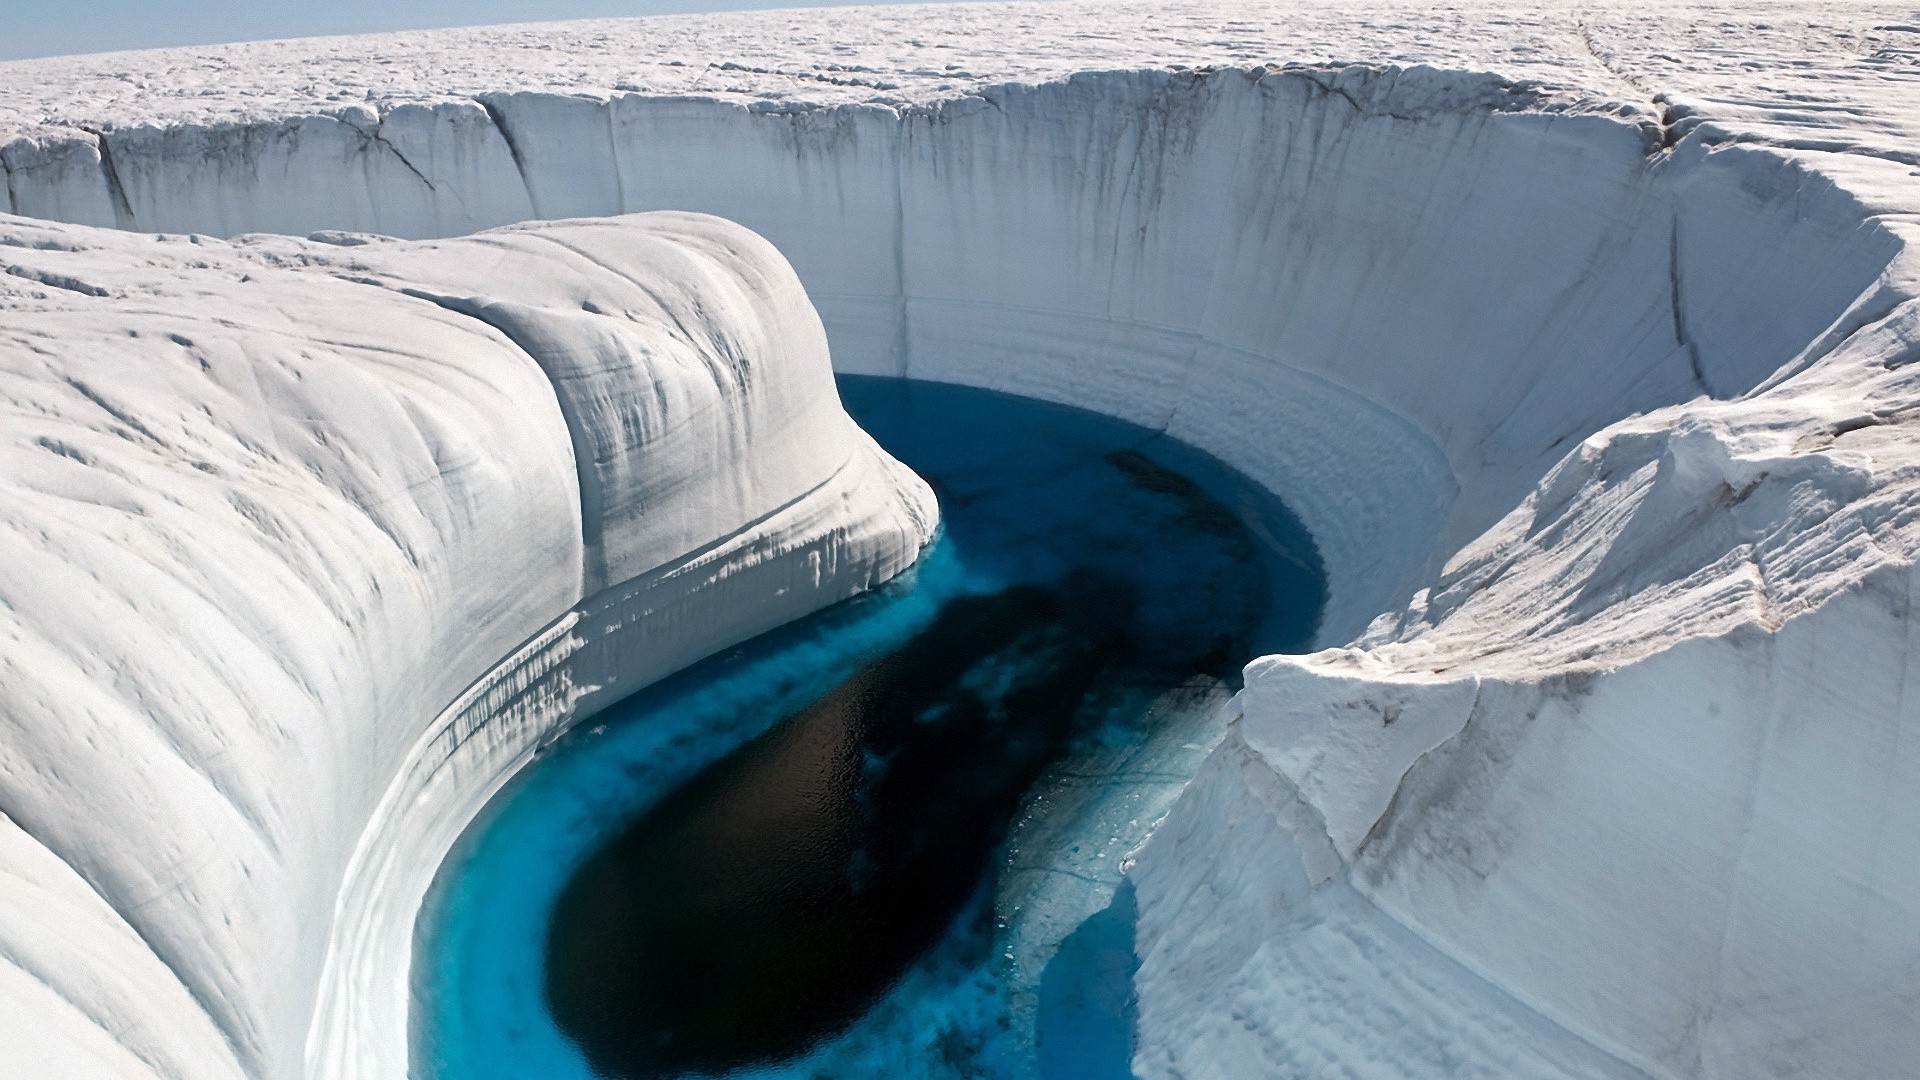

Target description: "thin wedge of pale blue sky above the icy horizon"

left=0, top=0, right=960, bottom=60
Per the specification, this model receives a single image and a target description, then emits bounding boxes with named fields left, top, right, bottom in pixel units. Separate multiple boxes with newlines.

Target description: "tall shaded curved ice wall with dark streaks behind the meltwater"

left=0, top=67, right=1889, bottom=642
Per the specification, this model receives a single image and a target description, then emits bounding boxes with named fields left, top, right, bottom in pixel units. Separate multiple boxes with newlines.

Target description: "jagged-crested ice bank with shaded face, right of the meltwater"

left=1135, top=225, right=1920, bottom=1080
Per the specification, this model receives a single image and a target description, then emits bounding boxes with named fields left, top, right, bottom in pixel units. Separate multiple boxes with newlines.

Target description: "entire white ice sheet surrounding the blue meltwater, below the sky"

left=0, top=0, right=1920, bottom=1080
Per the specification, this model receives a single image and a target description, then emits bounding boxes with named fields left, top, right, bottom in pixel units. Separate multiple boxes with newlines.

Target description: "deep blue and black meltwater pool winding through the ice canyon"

left=413, top=377, right=1327, bottom=1080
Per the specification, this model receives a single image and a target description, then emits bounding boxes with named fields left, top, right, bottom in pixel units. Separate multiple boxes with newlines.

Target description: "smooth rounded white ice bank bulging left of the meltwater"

left=0, top=213, right=933, bottom=1076
